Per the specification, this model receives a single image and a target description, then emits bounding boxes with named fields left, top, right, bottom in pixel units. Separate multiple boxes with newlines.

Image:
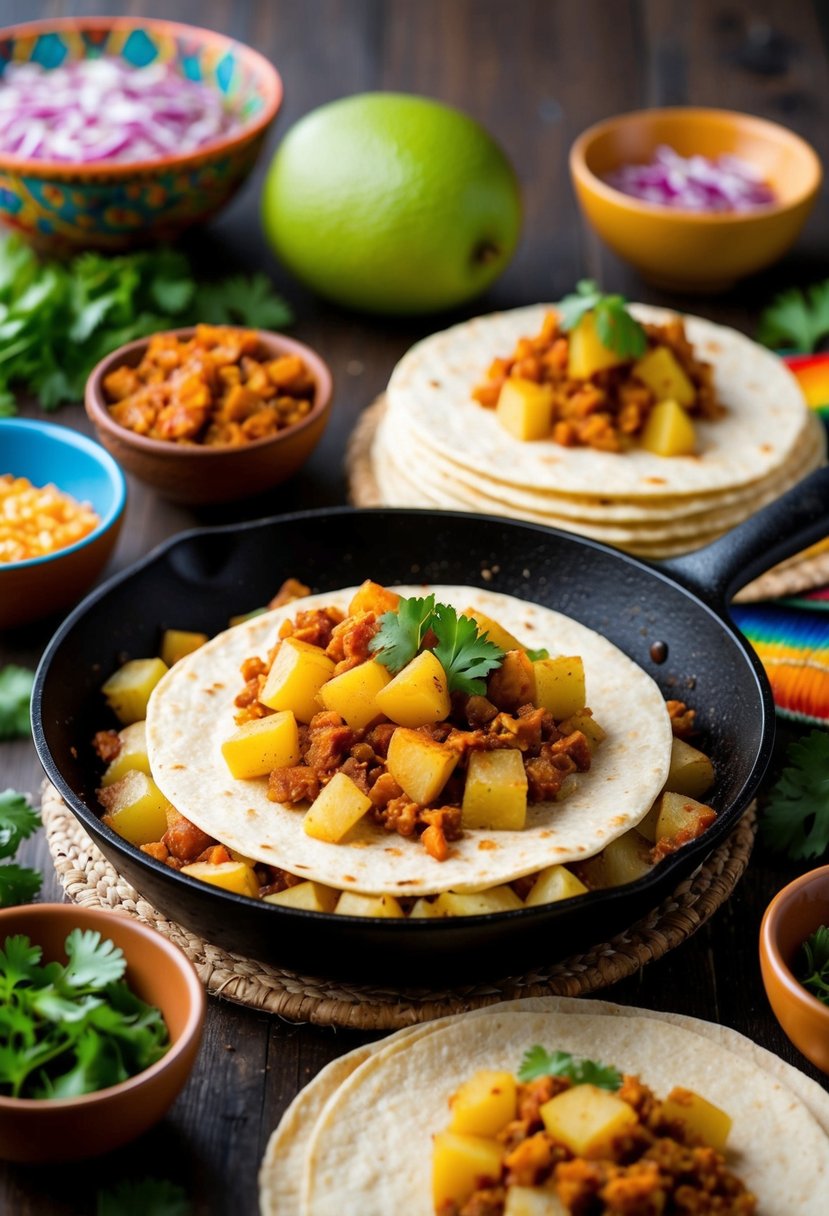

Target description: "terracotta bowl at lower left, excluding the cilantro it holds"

left=0, top=903, right=205, bottom=1162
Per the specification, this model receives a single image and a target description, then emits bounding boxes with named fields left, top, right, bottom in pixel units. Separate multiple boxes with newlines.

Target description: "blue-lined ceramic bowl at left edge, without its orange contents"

left=0, top=418, right=126, bottom=629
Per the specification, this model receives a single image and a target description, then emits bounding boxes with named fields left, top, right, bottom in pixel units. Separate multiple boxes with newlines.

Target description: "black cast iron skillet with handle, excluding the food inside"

left=33, top=468, right=829, bottom=986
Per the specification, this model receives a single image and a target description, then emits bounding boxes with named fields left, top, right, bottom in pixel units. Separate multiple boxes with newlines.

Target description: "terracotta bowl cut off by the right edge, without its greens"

left=760, top=866, right=829, bottom=1073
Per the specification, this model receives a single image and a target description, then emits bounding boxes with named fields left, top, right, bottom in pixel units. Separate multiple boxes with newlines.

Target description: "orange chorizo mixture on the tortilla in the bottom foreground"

left=435, top=1053, right=757, bottom=1216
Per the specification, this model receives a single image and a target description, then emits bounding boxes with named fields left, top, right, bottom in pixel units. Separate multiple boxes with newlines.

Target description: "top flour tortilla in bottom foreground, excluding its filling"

left=296, top=998, right=829, bottom=1216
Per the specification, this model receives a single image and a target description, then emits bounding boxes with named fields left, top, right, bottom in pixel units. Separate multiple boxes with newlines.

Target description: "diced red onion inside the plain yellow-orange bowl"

left=604, top=145, right=777, bottom=212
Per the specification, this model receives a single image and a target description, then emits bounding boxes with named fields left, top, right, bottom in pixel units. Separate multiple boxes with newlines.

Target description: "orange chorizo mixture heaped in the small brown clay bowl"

left=103, top=325, right=315, bottom=446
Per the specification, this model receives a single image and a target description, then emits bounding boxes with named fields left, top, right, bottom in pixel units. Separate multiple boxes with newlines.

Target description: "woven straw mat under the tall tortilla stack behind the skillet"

left=345, top=394, right=829, bottom=603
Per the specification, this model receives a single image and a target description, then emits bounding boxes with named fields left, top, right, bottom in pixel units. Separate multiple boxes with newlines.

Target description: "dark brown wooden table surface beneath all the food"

left=0, top=0, right=829, bottom=1216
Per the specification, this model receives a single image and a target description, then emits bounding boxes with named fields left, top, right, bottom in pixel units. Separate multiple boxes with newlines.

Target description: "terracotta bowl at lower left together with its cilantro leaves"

left=0, top=903, right=205, bottom=1162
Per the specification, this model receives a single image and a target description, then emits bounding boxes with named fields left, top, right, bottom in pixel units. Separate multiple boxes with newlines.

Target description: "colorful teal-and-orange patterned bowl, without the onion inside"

left=0, top=17, right=282, bottom=254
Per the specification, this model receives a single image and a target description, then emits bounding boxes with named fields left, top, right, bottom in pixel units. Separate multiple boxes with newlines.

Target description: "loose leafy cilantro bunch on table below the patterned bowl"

left=0, top=236, right=292, bottom=417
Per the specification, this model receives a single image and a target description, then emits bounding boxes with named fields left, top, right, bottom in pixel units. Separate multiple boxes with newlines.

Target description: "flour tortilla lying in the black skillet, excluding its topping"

left=147, top=586, right=671, bottom=895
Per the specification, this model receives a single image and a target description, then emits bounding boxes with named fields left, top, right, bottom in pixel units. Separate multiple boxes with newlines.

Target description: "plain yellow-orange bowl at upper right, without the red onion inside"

left=570, top=107, right=823, bottom=293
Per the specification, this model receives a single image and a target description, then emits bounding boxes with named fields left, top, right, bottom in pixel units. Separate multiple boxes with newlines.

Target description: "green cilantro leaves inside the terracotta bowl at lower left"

left=0, top=929, right=169, bottom=1098
